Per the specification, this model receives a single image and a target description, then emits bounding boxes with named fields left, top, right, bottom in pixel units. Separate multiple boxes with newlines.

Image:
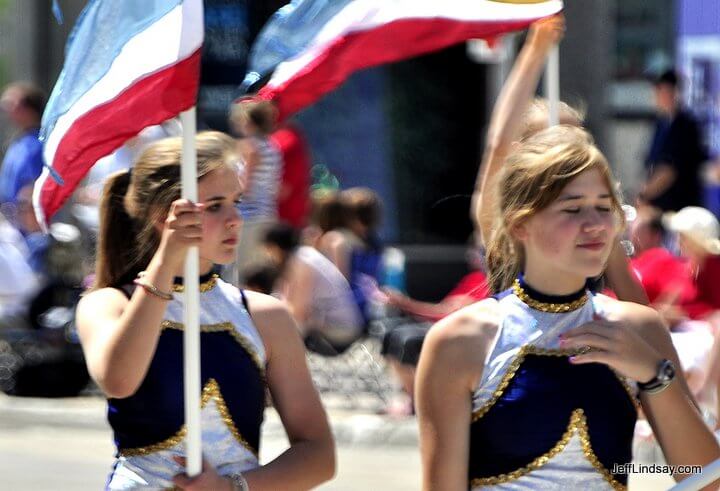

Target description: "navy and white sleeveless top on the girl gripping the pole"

left=106, top=275, right=266, bottom=490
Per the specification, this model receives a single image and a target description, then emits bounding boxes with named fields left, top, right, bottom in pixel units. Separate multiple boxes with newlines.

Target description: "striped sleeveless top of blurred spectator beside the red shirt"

left=240, top=137, right=282, bottom=220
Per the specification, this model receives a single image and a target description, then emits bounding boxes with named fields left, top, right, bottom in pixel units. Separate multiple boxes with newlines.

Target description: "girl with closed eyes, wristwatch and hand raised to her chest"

left=416, top=126, right=720, bottom=490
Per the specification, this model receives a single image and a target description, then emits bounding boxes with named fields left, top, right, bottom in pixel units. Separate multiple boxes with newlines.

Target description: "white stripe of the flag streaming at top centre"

left=268, top=0, right=563, bottom=87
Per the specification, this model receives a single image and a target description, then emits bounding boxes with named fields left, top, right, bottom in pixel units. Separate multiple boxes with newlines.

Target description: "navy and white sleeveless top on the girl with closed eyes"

left=469, top=282, right=639, bottom=490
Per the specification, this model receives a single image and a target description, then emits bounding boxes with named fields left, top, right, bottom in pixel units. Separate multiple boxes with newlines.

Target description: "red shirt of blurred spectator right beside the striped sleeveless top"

left=270, top=125, right=310, bottom=230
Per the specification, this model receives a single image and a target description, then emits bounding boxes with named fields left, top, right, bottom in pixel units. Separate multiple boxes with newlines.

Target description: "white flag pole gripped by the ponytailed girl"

left=180, top=107, right=202, bottom=476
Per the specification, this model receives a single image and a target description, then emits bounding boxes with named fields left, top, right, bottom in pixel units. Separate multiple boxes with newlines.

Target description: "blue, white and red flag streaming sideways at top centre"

left=244, top=0, right=563, bottom=118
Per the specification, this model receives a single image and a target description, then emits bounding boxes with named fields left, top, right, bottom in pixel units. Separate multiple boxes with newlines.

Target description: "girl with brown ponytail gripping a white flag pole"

left=77, top=132, right=334, bottom=490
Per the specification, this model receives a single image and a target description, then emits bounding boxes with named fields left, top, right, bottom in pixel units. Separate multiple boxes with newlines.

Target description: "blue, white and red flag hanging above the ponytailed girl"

left=33, top=0, right=204, bottom=225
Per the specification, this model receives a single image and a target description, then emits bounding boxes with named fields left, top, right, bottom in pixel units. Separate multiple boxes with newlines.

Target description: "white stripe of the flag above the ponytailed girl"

left=44, top=1, right=203, bottom=169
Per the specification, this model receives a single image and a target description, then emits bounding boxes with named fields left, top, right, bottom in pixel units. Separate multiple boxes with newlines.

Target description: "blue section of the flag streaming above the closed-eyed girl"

left=241, top=0, right=355, bottom=93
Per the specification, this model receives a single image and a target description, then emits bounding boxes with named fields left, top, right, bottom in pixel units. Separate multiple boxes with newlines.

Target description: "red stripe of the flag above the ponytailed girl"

left=40, top=49, right=200, bottom=220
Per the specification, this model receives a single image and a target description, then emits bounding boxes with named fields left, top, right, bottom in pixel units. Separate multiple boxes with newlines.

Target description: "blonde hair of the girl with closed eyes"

left=486, top=125, right=625, bottom=292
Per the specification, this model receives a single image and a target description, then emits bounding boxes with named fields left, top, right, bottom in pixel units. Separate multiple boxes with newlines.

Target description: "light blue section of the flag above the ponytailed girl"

left=40, top=0, right=182, bottom=140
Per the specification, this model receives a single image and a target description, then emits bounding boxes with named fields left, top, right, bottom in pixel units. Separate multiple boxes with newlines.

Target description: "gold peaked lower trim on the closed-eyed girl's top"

left=470, top=409, right=627, bottom=490
